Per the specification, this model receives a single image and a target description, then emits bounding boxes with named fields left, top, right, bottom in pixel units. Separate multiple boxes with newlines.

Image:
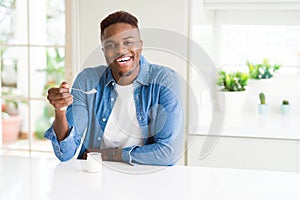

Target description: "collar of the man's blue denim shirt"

left=104, top=55, right=150, bottom=86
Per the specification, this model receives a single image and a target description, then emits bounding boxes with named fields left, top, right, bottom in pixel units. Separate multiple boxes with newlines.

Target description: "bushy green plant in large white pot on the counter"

left=217, top=70, right=249, bottom=114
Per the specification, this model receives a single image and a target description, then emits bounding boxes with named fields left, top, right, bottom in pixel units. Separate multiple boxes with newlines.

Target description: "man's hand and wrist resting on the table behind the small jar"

left=81, top=148, right=123, bottom=162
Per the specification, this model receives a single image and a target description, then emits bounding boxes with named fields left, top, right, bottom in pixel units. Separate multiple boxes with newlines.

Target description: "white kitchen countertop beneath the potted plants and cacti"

left=190, top=113, right=300, bottom=140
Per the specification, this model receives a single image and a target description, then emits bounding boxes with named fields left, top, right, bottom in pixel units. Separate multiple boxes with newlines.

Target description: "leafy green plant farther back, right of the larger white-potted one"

left=247, top=58, right=280, bottom=79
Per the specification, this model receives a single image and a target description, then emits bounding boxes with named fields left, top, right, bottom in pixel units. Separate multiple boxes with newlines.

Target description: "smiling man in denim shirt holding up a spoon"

left=45, top=11, right=183, bottom=165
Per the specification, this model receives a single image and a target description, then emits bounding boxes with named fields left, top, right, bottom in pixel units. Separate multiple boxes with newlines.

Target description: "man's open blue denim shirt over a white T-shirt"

left=44, top=56, right=183, bottom=165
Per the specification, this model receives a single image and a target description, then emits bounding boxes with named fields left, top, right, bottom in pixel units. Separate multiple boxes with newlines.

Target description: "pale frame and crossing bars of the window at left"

left=0, top=0, right=74, bottom=154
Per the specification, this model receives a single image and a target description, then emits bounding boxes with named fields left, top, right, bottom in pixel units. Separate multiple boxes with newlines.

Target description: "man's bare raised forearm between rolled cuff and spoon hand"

left=53, top=110, right=69, bottom=142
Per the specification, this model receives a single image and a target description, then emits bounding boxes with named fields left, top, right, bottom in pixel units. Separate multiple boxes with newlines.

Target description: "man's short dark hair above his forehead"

left=100, top=10, right=139, bottom=35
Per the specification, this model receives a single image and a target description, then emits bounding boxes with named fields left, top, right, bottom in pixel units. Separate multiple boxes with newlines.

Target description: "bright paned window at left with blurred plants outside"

left=0, top=0, right=68, bottom=156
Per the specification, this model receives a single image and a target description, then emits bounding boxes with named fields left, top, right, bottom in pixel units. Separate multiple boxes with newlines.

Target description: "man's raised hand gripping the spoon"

left=47, top=82, right=73, bottom=111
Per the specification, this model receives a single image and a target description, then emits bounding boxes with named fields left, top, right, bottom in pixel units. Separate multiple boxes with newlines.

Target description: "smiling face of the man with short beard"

left=101, top=23, right=143, bottom=81
